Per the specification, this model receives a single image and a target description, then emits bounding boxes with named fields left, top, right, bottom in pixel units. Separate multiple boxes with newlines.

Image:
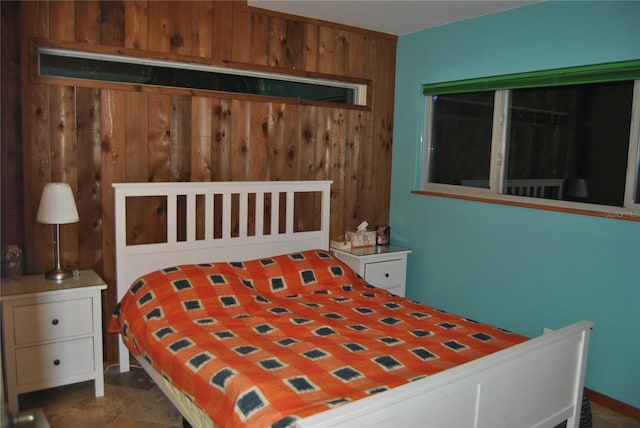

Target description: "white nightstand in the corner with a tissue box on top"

left=331, top=245, right=411, bottom=297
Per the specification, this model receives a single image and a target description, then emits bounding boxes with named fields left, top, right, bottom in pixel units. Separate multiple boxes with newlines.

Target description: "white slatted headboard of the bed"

left=113, top=181, right=331, bottom=300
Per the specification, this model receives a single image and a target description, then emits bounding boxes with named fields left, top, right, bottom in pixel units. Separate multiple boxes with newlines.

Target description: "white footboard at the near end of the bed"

left=298, top=321, right=593, bottom=428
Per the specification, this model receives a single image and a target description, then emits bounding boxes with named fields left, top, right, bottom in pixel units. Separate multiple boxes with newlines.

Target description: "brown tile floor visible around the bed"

left=12, top=367, right=640, bottom=428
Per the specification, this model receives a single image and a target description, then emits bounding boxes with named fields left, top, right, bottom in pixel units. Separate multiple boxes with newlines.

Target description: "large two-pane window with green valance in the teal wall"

left=423, top=61, right=640, bottom=217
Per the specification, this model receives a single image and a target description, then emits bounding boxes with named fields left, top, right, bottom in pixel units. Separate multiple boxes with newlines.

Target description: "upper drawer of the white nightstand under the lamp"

left=13, top=298, right=93, bottom=345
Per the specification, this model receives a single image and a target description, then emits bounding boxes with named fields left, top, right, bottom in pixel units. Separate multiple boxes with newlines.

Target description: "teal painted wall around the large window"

left=390, top=1, right=640, bottom=408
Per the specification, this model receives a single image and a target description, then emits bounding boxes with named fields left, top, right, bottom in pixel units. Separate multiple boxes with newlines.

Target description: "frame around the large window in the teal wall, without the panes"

left=414, top=60, right=640, bottom=221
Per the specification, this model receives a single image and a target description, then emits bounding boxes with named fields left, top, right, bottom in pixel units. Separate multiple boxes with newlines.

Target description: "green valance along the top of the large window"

left=422, top=60, right=640, bottom=95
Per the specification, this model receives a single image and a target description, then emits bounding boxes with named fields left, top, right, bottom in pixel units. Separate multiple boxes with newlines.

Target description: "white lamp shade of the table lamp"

left=37, top=183, right=80, bottom=224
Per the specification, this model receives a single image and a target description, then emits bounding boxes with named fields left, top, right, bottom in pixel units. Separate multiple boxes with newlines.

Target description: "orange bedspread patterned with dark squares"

left=109, top=250, right=526, bottom=427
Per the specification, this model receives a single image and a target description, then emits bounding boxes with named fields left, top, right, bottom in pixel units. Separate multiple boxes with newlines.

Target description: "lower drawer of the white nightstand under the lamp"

left=16, top=337, right=95, bottom=386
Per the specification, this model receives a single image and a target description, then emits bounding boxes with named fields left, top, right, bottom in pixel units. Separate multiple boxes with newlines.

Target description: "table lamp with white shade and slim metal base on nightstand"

left=37, top=183, right=79, bottom=281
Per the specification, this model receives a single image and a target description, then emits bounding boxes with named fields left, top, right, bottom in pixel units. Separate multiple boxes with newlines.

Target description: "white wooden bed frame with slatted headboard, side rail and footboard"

left=114, top=181, right=593, bottom=428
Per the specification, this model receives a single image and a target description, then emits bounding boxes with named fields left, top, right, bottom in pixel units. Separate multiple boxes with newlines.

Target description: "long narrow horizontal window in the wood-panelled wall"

left=38, top=47, right=366, bottom=106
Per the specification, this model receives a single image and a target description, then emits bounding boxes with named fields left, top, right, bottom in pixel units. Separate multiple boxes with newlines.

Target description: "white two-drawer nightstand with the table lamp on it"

left=0, top=270, right=107, bottom=414
